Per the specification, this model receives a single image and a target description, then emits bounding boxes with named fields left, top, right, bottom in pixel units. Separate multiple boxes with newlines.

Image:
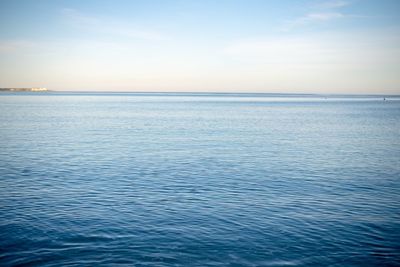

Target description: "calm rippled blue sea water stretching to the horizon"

left=0, top=93, right=400, bottom=266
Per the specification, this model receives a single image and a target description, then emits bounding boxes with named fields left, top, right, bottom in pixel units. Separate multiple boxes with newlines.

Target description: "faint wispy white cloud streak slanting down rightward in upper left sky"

left=62, top=8, right=169, bottom=41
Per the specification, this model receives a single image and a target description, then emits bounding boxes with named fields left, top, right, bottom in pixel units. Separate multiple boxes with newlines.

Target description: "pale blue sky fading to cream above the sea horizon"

left=0, top=0, right=400, bottom=94
